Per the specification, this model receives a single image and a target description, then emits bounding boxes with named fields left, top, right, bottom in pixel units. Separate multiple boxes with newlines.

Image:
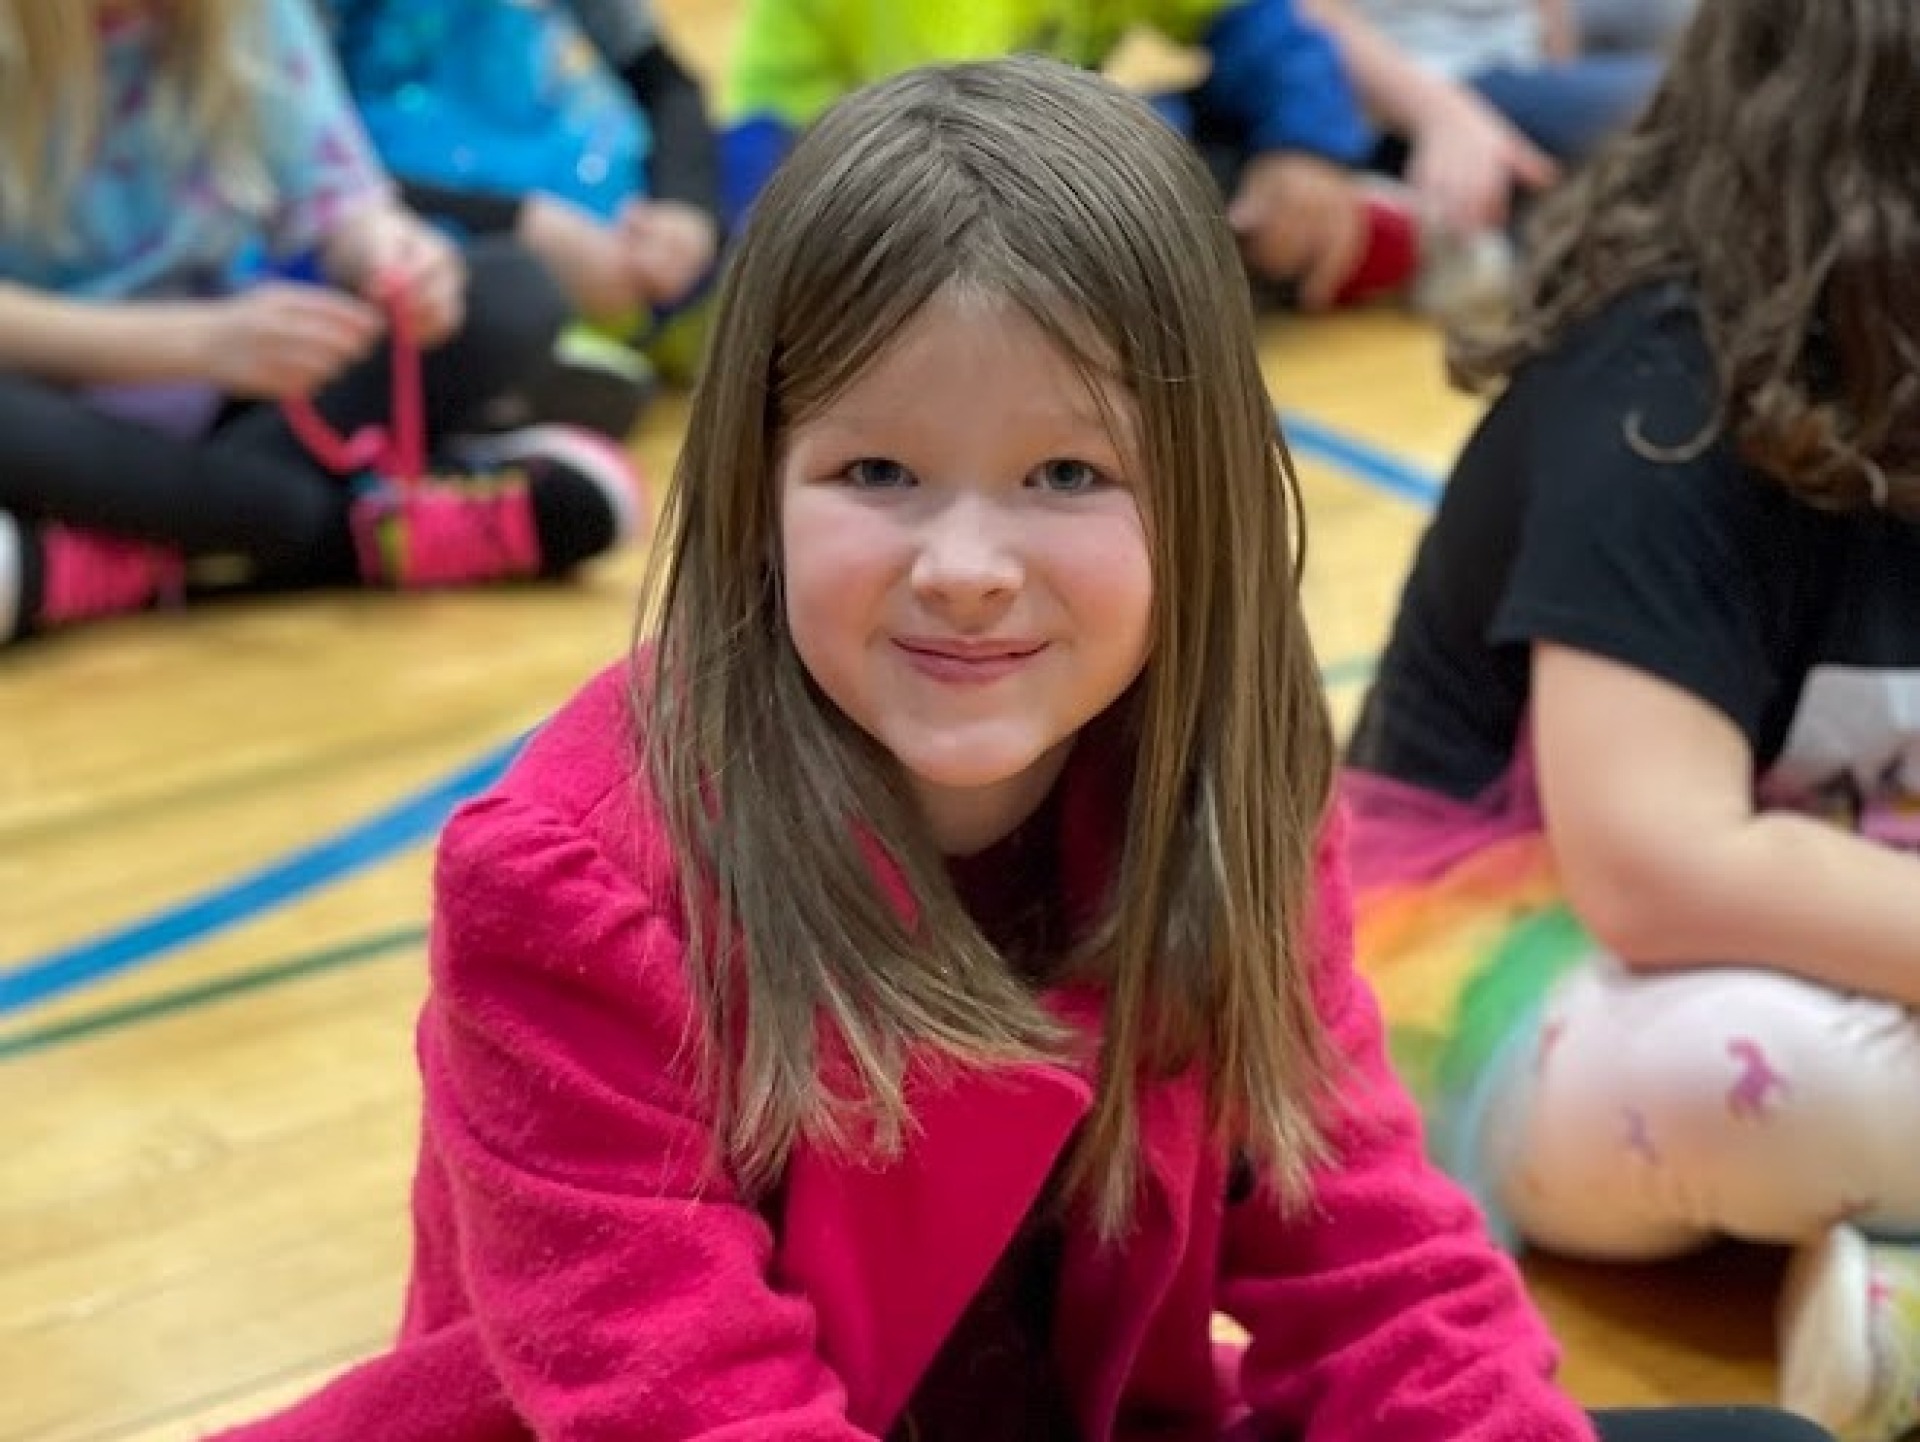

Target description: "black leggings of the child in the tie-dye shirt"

left=0, top=242, right=566, bottom=588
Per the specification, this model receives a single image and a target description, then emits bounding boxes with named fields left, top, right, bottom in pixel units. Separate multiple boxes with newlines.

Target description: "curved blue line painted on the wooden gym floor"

left=0, top=413, right=1440, bottom=1016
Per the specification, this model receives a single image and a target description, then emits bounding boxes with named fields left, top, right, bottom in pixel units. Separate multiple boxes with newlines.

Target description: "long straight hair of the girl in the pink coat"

left=636, top=50, right=1332, bottom=1233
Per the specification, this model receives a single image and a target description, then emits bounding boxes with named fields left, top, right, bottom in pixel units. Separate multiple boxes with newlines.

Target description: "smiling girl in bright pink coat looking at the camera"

left=214, top=60, right=1818, bottom=1442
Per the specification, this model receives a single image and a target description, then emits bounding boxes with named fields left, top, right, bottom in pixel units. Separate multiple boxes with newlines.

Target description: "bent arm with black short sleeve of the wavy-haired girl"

left=1489, top=299, right=1920, bottom=1004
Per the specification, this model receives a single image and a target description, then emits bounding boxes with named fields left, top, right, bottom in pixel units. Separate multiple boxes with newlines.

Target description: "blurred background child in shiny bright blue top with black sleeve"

left=328, top=0, right=720, bottom=434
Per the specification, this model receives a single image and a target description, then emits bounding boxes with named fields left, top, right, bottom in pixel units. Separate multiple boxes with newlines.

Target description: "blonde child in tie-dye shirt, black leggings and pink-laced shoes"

left=0, top=0, right=636, bottom=643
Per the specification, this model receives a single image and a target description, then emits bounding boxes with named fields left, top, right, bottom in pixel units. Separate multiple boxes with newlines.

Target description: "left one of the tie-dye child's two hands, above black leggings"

left=200, top=282, right=386, bottom=401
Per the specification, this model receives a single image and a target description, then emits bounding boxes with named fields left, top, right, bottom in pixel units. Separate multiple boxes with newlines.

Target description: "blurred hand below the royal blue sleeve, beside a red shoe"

left=1227, top=150, right=1367, bottom=311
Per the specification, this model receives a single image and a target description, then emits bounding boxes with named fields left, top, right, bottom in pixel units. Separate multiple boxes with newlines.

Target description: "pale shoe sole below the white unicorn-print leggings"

left=1780, top=1227, right=1874, bottom=1432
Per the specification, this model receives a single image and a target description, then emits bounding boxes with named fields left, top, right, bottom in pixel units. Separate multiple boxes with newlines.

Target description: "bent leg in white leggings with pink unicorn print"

left=1484, top=956, right=1920, bottom=1258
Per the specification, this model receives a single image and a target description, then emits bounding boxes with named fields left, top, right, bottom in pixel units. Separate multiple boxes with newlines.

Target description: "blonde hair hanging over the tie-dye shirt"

left=0, top=0, right=265, bottom=244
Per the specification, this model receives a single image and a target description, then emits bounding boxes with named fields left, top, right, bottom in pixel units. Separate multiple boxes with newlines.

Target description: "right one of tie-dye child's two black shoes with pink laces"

left=351, top=426, right=639, bottom=589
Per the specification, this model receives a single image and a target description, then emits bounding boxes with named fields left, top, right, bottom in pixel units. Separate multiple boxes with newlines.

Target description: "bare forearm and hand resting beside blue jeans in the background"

left=1302, top=0, right=1557, bottom=230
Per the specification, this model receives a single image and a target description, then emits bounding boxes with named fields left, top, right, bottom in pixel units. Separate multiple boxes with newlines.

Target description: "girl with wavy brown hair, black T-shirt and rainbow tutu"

left=1348, top=0, right=1920, bottom=1442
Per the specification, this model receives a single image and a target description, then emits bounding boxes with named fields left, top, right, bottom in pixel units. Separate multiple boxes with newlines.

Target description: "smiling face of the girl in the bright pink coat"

left=778, top=296, right=1154, bottom=854
